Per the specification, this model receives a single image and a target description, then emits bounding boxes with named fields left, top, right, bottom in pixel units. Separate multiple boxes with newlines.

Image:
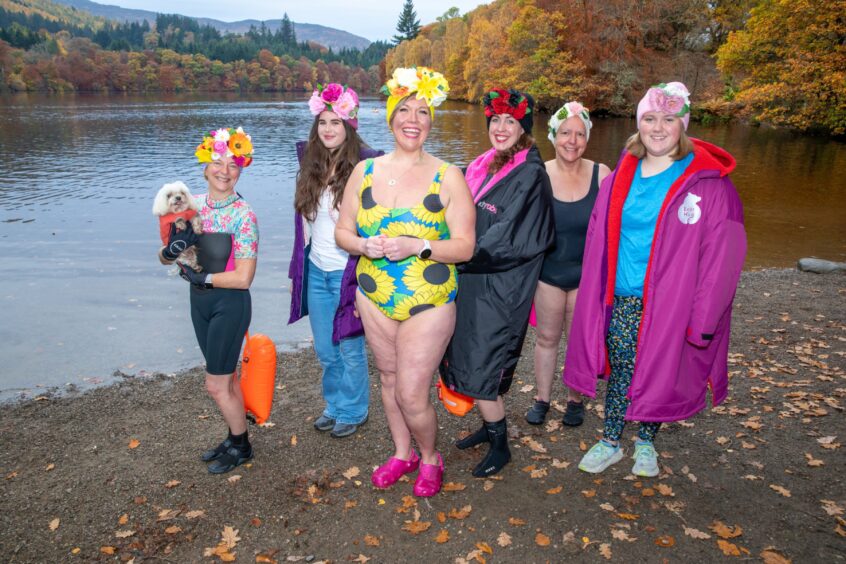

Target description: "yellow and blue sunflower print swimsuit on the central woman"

left=356, top=159, right=458, bottom=321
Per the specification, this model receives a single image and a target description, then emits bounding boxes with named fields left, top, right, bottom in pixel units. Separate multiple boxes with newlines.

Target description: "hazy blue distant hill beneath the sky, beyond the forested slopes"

left=49, top=0, right=370, bottom=51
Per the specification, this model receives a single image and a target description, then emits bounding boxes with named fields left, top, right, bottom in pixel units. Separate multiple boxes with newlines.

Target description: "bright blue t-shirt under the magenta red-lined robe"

left=614, top=153, right=693, bottom=298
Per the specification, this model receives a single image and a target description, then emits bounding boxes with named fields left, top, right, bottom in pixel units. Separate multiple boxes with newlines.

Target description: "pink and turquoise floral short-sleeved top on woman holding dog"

left=194, top=193, right=258, bottom=259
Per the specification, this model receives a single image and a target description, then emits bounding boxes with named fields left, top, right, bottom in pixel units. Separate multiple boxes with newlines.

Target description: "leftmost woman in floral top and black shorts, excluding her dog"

left=159, top=127, right=258, bottom=474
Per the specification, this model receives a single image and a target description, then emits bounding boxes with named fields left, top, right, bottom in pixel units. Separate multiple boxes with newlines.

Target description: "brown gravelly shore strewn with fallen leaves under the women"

left=0, top=270, right=846, bottom=562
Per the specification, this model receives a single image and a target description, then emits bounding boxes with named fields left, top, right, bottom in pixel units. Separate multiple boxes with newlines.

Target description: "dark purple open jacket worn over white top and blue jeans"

left=288, top=141, right=385, bottom=343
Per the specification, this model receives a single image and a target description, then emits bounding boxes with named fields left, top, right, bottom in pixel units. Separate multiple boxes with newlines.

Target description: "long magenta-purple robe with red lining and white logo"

left=563, top=139, right=746, bottom=421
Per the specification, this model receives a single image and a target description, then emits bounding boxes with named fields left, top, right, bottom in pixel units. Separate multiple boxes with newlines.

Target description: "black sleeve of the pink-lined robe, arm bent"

left=458, top=165, right=555, bottom=274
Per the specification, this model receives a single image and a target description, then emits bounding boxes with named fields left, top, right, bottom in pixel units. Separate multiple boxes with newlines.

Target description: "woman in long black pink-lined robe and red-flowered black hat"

left=441, top=89, right=555, bottom=477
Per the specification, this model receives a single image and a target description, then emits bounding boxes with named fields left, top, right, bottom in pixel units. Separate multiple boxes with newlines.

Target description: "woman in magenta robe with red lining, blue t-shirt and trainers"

left=564, top=82, right=746, bottom=476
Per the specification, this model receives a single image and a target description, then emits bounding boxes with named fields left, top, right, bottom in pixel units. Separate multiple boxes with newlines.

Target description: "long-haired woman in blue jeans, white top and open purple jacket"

left=288, top=83, right=382, bottom=438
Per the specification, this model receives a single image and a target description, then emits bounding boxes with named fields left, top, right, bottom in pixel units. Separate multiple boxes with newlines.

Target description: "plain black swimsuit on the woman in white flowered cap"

left=540, top=163, right=599, bottom=291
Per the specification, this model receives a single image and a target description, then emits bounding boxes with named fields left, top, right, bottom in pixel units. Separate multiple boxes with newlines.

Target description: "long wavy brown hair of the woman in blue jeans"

left=294, top=116, right=365, bottom=221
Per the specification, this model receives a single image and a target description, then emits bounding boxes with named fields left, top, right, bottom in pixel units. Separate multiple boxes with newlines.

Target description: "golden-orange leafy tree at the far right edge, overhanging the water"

left=717, top=0, right=846, bottom=135
